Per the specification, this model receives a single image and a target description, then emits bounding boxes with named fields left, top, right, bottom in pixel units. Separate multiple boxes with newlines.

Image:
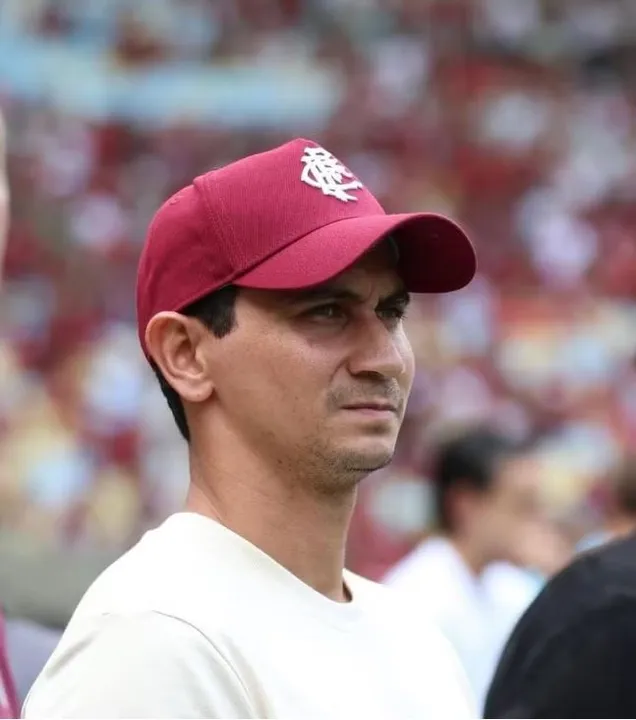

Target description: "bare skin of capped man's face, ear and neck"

left=146, top=245, right=414, bottom=600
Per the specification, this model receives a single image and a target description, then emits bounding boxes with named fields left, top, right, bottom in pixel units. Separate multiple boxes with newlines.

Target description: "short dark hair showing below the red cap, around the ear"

left=150, top=285, right=238, bottom=442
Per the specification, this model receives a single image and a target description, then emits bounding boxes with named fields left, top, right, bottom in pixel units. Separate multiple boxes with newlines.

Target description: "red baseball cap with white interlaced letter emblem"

left=137, top=138, right=476, bottom=352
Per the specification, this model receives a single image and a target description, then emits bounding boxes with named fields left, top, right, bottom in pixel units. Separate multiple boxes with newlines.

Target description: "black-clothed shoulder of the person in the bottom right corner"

left=485, top=534, right=636, bottom=718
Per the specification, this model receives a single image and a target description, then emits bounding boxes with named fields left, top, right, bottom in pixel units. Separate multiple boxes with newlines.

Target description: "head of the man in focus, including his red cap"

left=137, top=140, right=475, bottom=491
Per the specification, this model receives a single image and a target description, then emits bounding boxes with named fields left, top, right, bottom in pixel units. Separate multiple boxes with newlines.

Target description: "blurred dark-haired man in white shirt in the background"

left=385, top=427, right=568, bottom=703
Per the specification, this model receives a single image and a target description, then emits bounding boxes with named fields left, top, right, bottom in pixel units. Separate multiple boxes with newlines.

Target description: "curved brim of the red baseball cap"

left=234, top=213, right=477, bottom=293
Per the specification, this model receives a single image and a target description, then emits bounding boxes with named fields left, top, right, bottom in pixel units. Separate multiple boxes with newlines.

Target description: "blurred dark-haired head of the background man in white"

left=433, top=427, right=540, bottom=561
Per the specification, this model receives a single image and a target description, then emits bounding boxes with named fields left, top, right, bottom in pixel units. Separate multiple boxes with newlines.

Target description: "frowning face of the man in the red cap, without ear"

left=201, top=246, right=414, bottom=493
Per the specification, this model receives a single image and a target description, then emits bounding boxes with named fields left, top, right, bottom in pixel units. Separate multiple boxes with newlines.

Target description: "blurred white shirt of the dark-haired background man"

left=384, top=538, right=540, bottom=707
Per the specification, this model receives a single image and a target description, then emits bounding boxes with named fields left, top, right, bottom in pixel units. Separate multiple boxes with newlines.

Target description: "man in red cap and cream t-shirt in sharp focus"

left=24, top=139, right=475, bottom=718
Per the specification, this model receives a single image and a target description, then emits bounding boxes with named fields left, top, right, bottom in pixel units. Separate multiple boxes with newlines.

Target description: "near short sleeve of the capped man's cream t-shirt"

left=23, top=612, right=256, bottom=718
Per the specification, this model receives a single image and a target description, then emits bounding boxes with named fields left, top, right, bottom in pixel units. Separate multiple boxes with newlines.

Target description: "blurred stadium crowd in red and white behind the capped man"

left=0, top=0, right=636, bottom=612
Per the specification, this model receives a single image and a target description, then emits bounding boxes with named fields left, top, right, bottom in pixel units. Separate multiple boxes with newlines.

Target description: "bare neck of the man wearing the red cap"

left=186, top=444, right=356, bottom=602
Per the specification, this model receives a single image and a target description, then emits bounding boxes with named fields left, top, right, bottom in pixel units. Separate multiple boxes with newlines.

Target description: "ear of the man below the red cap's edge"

left=145, top=312, right=214, bottom=403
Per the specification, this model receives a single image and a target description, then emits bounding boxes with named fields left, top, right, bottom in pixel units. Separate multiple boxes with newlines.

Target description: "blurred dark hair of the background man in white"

left=432, top=427, right=520, bottom=531
